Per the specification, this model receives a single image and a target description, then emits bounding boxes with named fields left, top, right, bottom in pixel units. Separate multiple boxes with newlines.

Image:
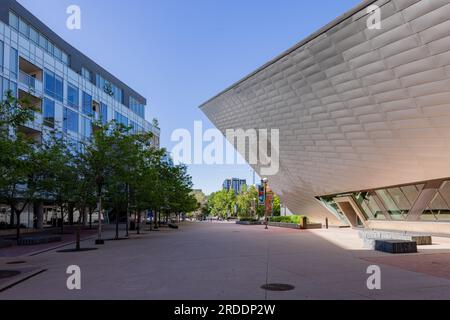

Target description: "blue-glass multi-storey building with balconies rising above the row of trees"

left=0, top=0, right=160, bottom=229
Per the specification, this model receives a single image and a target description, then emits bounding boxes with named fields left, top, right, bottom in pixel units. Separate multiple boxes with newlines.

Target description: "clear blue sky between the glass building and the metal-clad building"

left=19, top=0, right=361, bottom=193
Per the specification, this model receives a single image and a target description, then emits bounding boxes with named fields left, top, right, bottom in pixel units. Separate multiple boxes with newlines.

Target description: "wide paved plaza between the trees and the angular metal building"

left=0, top=223, right=450, bottom=300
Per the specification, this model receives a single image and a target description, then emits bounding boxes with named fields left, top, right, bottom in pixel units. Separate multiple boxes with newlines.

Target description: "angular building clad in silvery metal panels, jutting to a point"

left=201, top=0, right=450, bottom=234
